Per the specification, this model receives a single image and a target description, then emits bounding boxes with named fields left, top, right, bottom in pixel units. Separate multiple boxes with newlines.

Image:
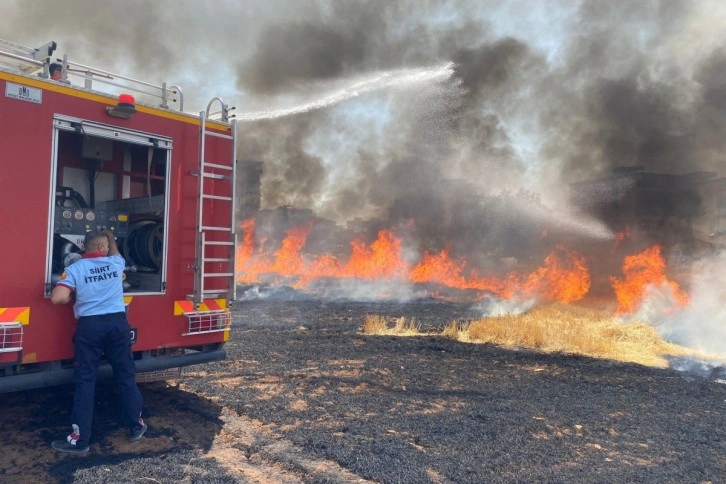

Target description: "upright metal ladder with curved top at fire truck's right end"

left=191, top=98, right=237, bottom=310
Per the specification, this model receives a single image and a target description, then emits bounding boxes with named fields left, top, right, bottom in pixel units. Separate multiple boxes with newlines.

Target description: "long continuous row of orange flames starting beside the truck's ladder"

left=237, top=221, right=590, bottom=302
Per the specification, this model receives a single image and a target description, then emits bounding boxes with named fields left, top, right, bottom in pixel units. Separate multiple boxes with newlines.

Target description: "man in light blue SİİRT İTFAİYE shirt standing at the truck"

left=51, top=231, right=147, bottom=454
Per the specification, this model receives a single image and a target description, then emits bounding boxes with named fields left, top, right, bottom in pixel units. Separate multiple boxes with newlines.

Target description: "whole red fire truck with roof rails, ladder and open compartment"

left=0, top=41, right=236, bottom=393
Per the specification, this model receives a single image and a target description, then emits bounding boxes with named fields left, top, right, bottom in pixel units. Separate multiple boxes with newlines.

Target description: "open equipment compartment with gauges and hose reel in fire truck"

left=47, top=116, right=171, bottom=294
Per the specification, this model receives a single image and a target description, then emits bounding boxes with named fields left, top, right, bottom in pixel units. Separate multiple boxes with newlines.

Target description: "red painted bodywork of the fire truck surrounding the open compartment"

left=0, top=70, right=234, bottom=391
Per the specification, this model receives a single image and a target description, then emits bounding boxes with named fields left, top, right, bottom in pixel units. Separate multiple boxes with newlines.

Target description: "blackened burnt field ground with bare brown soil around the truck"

left=0, top=299, right=726, bottom=483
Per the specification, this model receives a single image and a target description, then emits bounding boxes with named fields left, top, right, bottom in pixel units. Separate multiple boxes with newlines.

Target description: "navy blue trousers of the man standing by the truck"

left=71, top=313, right=144, bottom=447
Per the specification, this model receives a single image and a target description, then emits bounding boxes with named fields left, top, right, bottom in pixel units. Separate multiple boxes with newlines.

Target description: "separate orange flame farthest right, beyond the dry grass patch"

left=610, top=245, right=689, bottom=314
